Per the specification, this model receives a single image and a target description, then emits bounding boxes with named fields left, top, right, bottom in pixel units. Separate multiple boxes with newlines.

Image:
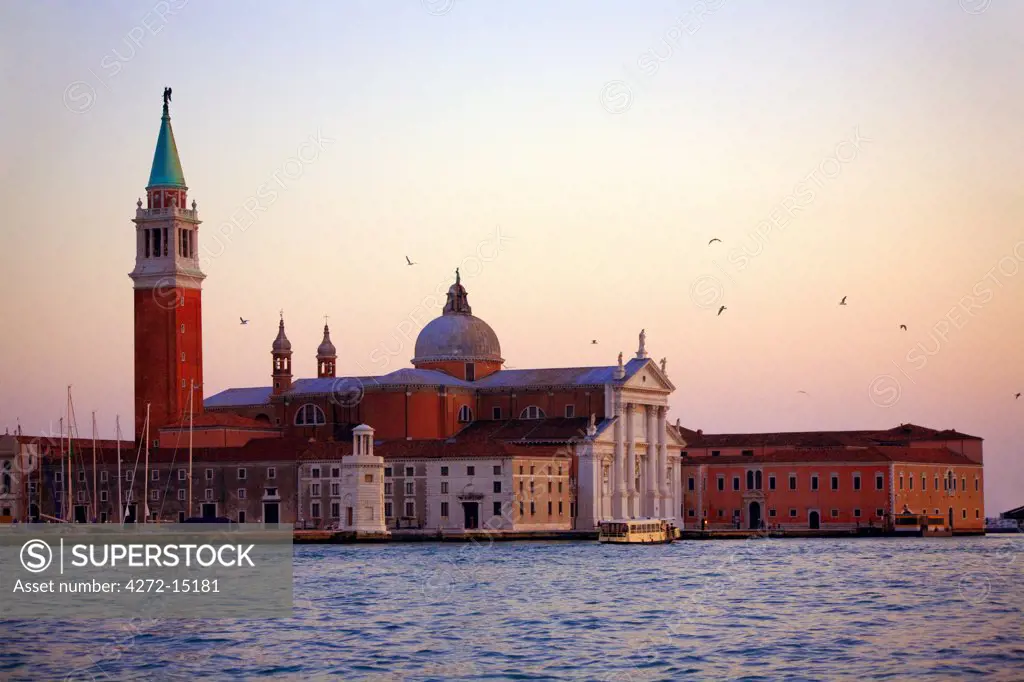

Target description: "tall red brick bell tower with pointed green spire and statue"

left=128, top=88, right=206, bottom=440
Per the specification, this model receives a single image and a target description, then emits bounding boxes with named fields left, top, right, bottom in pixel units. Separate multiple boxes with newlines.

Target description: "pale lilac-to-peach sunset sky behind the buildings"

left=0, top=0, right=1024, bottom=515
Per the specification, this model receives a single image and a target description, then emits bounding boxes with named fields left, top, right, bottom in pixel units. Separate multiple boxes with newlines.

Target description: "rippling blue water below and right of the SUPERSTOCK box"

left=0, top=535, right=1024, bottom=681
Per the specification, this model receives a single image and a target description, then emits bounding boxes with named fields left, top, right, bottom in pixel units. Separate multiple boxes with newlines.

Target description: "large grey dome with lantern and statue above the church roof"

left=413, top=270, right=504, bottom=365
